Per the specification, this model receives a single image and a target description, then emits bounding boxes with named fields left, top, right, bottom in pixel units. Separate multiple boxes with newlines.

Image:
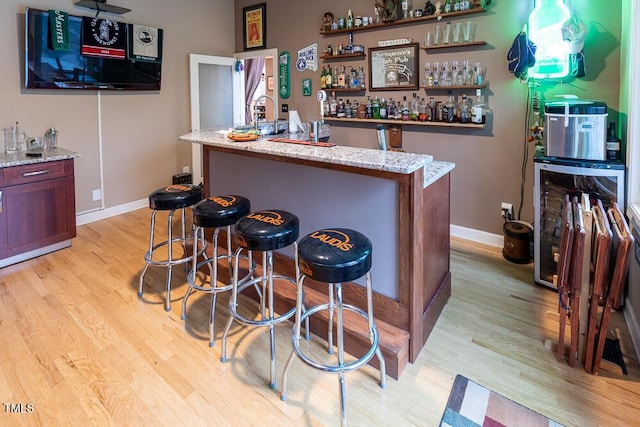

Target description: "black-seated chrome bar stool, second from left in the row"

left=182, top=195, right=253, bottom=347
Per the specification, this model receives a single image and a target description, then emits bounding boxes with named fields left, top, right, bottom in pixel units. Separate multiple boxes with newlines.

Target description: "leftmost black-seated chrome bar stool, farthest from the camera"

left=138, top=184, right=202, bottom=311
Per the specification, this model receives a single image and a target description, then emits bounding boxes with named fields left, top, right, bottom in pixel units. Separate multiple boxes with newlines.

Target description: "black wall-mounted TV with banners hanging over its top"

left=25, top=8, right=163, bottom=90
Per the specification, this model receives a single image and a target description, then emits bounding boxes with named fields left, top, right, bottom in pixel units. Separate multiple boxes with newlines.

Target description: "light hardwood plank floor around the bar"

left=0, top=209, right=640, bottom=427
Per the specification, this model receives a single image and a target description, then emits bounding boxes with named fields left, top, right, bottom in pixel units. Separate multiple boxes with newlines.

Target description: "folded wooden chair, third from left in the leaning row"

left=584, top=200, right=612, bottom=373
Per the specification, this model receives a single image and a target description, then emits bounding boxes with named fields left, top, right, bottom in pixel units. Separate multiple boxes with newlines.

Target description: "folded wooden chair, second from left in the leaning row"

left=569, top=197, right=585, bottom=367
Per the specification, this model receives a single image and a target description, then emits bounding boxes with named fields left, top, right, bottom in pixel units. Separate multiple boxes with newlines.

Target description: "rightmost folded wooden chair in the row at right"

left=591, top=202, right=634, bottom=374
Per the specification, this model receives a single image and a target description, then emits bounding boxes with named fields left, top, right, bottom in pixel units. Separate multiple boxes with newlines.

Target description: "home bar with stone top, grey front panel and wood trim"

left=180, top=130, right=454, bottom=379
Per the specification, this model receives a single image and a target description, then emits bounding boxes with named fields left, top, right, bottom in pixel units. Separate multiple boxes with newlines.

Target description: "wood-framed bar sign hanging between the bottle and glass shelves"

left=369, top=43, right=420, bottom=91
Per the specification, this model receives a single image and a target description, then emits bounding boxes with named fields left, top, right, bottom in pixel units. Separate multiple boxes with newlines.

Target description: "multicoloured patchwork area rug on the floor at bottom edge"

left=440, top=375, right=563, bottom=427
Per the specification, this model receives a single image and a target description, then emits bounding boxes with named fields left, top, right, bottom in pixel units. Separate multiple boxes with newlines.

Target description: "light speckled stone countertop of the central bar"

left=179, top=130, right=455, bottom=187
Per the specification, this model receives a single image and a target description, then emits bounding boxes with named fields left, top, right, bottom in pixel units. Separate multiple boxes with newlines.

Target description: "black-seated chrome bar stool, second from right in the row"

left=220, top=210, right=300, bottom=389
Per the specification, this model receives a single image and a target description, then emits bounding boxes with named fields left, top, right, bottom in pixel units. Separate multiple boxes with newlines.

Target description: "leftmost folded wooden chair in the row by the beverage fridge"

left=556, top=194, right=574, bottom=360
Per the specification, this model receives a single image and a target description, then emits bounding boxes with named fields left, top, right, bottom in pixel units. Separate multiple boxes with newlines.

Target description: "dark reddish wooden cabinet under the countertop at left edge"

left=0, top=159, right=76, bottom=266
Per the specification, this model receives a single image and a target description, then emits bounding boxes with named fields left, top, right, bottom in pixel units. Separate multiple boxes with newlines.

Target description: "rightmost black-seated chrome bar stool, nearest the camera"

left=280, top=228, right=386, bottom=425
